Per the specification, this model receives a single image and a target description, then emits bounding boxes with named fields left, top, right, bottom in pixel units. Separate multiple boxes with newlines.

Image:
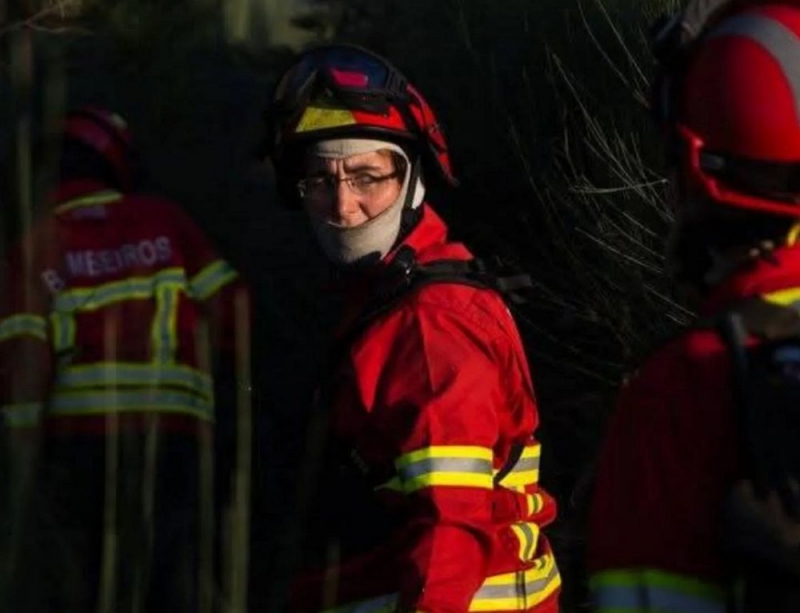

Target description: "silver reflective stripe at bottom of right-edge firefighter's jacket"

left=593, top=585, right=725, bottom=613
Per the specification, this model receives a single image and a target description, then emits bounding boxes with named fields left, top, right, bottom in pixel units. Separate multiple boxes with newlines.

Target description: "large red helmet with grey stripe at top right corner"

left=655, top=0, right=800, bottom=216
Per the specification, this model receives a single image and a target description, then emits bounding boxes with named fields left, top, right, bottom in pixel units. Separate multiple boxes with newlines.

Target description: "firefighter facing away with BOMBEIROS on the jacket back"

left=0, top=107, right=244, bottom=611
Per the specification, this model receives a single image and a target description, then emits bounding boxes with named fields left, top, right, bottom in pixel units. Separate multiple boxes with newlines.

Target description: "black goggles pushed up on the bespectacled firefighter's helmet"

left=272, top=45, right=409, bottom=114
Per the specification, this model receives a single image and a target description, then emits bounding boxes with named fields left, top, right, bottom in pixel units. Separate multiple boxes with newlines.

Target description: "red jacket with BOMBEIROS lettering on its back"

left=0, top=181, right=244, bottom=433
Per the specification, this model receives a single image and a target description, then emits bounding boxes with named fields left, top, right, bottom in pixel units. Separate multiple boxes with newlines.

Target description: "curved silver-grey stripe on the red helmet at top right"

left=709, top=13, right=800, bottom=120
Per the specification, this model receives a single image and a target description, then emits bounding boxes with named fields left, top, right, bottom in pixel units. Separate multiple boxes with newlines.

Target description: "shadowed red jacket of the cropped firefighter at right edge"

left=589, top=247, right=800, bottom=613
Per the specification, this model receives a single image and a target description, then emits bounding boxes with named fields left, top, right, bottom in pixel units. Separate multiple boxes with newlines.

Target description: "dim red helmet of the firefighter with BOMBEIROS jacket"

left=64, top=106, right=134, bottom=189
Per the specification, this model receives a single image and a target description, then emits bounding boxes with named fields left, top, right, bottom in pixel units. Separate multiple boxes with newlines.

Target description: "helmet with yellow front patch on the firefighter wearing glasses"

left=266, top=45, right=457, bottom=202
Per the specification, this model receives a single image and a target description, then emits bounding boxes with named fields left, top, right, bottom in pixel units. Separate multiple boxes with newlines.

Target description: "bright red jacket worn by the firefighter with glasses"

left=295, top=205, right=560, bottom=613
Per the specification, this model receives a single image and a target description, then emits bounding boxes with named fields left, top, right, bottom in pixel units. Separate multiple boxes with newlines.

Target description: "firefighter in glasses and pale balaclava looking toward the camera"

left=268, top=46, right=560, bottom=613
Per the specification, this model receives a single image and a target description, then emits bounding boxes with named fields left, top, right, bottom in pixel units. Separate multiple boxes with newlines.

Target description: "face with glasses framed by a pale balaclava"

left=303, top=151, right=403, bottom=228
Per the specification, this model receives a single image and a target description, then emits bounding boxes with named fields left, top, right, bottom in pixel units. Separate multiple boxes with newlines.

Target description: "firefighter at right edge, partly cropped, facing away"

left=589, top=1, right=800, bottom=613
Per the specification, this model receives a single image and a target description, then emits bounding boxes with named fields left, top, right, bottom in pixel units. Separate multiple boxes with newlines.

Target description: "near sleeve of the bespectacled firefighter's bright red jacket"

left=346, top=308, right=504, bottom=613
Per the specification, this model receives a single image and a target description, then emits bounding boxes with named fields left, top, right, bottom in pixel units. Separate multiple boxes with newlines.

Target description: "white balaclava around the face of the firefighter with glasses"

left=309, top=138, right=425, bottom=266
